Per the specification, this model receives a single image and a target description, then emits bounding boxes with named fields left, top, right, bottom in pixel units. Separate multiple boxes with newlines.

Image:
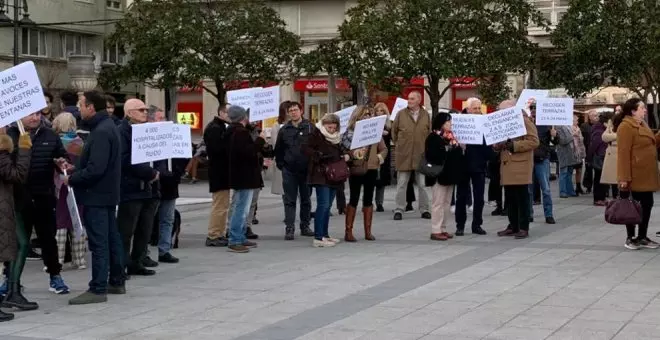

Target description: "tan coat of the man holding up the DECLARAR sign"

left=500, top=116, right=539, bottom=185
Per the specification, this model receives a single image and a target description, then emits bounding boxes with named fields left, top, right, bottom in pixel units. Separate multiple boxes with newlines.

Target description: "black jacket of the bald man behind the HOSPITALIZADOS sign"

left=118, top=117, right=156, bottom=202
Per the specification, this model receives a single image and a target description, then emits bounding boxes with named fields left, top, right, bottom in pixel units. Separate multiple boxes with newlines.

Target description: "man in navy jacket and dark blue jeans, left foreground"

left=64, top=91, right=126, bottom=305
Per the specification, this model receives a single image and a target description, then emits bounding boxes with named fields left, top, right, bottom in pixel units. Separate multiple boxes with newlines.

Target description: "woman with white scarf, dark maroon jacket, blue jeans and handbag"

left=303, top=113, right=348, bottom=248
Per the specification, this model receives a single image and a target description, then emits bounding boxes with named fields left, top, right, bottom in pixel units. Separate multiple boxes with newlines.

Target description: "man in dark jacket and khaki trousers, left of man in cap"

left=204, top=105, right=229, bottom=247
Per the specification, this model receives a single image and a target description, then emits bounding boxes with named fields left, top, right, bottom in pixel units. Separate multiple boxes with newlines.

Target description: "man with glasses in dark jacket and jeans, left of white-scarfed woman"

left=275, top=102, right=314, bottom=240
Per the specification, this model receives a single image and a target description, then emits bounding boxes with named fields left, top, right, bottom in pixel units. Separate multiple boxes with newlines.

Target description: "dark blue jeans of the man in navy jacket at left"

left=83, top=206, right=124, bottom=294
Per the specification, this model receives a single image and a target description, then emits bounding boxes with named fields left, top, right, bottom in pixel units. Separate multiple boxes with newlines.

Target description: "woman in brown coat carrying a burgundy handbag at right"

left=613, top=98, right=660, bottom=250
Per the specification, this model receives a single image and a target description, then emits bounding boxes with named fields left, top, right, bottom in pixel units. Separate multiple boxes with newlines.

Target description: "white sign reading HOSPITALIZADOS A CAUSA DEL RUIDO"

left=131, top=122, right=174, bottom=164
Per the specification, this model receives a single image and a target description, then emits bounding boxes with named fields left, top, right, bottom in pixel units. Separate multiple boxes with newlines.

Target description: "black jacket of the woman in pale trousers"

left=424, top=133, right=466, bottom=185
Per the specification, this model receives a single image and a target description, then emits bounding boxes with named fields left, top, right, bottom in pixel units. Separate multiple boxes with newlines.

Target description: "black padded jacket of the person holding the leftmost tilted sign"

left=7, top=124, right=69, bottom=196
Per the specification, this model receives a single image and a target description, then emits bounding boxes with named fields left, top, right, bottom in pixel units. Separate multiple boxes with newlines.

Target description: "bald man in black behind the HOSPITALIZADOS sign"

left=117, top=99, right=160, bottom=276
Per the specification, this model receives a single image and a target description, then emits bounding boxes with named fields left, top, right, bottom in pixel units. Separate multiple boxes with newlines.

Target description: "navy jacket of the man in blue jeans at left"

left=69, top=111, right=121, bottom=207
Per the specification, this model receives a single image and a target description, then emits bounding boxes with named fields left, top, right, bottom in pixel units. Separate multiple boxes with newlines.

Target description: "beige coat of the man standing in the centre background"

left=392, top=108, right=431, bottom=171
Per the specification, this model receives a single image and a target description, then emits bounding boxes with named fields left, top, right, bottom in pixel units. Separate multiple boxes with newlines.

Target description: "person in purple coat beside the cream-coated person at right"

left=587, top=114, right=612, bottom=207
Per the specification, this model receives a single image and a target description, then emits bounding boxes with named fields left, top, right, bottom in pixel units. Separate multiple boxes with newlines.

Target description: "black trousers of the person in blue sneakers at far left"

left=21, top=195, right=62, bottom=276
